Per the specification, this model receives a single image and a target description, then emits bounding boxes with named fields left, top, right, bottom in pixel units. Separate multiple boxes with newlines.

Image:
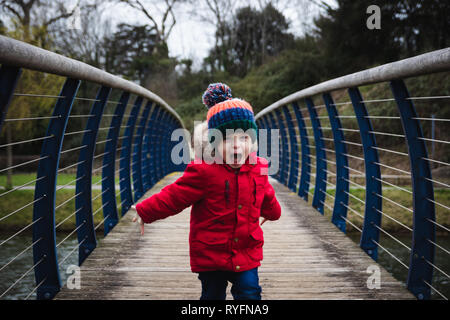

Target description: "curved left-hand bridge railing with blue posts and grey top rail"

left=0, top=36, right=190, bottom=299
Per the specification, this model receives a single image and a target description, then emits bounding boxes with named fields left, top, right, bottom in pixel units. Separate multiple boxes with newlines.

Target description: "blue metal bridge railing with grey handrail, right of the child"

left=255, top=48, right=450, bottom=299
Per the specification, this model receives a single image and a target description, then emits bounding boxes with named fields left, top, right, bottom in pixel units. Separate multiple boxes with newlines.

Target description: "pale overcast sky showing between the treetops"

left=106, top=0, right=335, bottom=69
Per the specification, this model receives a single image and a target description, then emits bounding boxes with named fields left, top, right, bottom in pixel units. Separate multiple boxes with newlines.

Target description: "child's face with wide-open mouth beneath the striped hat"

left=218, top=132, right=252, bottom=168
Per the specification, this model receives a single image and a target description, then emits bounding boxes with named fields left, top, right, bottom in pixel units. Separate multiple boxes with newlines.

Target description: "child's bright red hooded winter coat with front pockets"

left=136, top=153, right=281, bottom=272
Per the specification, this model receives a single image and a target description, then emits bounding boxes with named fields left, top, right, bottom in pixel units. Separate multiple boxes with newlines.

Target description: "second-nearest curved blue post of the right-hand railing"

left=348, top=88, right=382, bottom=261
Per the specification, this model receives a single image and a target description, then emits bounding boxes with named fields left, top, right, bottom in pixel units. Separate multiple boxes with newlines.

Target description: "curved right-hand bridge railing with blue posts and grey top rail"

left=255, top=48, right=450, bottom=299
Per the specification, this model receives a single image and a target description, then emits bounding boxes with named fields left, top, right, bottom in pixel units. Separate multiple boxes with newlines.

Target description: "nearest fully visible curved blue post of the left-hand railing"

left=33, top=78, right=80, bottom=300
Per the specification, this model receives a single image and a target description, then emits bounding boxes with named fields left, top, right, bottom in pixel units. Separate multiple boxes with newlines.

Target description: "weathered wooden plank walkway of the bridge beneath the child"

left=56, top=172, right=414, bottom=300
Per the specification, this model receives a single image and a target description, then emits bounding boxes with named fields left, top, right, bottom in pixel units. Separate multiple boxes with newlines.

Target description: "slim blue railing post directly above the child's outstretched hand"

left=132, top=101, right=152, bottom=202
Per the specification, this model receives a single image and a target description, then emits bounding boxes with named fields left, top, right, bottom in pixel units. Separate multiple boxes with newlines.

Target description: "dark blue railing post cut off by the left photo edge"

left=0, top=65, right=22, bottom=132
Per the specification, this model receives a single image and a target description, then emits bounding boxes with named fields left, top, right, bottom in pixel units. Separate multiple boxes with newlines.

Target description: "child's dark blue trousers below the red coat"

left=198, top=268, right=261, bottom=300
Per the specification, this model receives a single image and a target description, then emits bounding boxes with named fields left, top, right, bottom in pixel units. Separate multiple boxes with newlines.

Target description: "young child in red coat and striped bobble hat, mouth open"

left=133, top=83, right=281, bottom=300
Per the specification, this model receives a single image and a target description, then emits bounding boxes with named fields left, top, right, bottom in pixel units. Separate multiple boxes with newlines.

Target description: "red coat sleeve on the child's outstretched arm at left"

left=136, top=161, right=205, bottom=223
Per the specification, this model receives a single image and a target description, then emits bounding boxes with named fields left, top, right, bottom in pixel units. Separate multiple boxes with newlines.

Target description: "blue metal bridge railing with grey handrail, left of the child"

left=0, top=36, right=189, bottom=299
